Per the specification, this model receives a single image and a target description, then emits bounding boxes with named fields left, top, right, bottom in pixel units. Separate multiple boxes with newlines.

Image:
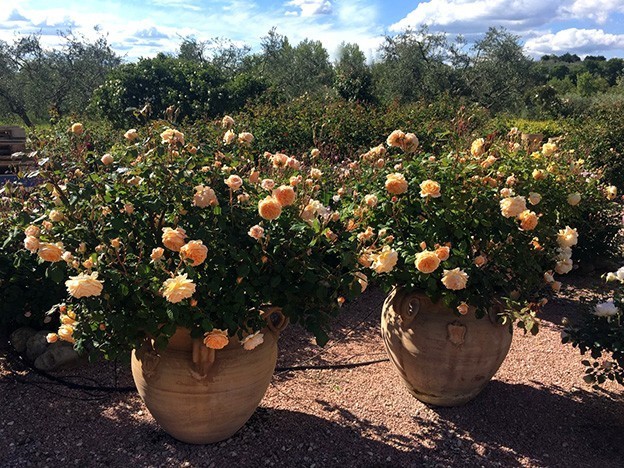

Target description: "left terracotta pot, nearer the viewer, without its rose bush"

left=132, top=310, right=287, bottom=444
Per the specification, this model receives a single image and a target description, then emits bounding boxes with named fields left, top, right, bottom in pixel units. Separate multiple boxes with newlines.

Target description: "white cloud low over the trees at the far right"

left=525, top=28, right=624, bottom=56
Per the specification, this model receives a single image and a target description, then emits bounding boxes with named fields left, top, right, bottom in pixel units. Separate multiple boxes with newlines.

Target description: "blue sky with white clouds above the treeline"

left=0, top=0, right=624, bottom=61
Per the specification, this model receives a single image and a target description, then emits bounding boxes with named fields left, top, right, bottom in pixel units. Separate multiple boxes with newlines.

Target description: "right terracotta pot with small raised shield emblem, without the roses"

left=381, top=288, right=512, bottom=406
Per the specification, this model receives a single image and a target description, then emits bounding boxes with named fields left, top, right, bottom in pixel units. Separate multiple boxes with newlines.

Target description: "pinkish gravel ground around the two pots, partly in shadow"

left=0, top=278, right=624, bottom=468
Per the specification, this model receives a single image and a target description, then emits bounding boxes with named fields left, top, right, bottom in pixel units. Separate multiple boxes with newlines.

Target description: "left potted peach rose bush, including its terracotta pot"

left=13, top=117, right=366, bottom=443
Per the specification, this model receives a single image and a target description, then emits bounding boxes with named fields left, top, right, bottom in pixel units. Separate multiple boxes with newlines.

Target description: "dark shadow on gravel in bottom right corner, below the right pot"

left=424, top=381, right=624, bottom=468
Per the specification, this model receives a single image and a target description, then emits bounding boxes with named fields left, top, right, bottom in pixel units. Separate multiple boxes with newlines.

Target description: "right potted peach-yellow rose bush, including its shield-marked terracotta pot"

left=342, top=130, right=606, bottom=406
